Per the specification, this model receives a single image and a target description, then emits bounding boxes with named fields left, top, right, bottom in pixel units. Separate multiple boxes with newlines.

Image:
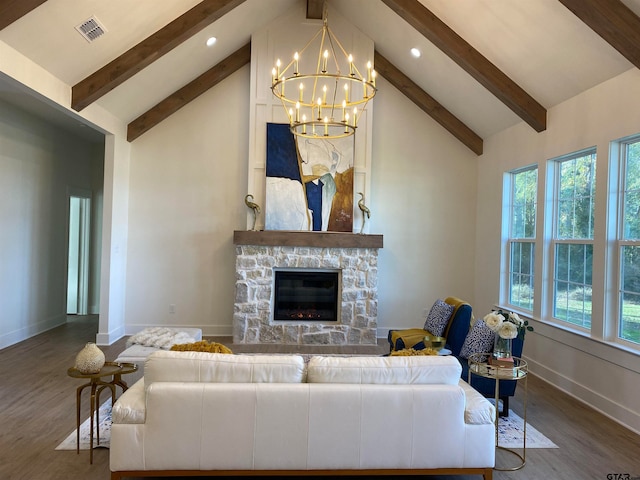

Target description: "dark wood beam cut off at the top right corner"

left=559, top=0, right=640, bottom=68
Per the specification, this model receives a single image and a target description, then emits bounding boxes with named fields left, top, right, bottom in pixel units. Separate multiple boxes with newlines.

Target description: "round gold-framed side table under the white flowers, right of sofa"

left=468, top=353, right=529, bottom=472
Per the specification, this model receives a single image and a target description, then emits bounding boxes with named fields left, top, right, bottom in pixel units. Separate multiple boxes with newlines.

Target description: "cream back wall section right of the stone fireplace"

left=370, top=78, right=479, bottom=337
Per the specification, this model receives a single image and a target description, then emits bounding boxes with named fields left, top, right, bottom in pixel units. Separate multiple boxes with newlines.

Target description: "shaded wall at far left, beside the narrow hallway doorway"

left=0, top=102, right=101, bottom=348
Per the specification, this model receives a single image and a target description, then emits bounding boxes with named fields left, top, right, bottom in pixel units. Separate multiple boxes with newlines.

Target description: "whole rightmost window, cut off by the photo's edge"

left=617, top=137, right=640, bottom=344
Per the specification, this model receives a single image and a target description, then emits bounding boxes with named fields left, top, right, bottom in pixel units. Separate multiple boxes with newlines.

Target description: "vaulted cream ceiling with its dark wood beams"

left=0, top=0, right=640, bottom=154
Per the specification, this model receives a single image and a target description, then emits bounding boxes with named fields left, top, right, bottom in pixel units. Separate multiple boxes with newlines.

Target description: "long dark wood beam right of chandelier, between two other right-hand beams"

left=376, top=0, right=547, bottom=132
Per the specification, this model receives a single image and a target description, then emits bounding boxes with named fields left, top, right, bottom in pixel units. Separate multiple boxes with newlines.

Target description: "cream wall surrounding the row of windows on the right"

left=474, top=69, right=640, bottom=432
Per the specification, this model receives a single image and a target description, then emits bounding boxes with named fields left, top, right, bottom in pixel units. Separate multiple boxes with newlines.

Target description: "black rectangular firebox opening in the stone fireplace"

left=273, top=270, right=340, bottom=322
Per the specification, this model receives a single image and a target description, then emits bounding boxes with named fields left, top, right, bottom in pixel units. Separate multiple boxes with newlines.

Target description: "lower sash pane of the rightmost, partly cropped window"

left=618, top=246, right=640, bottom=344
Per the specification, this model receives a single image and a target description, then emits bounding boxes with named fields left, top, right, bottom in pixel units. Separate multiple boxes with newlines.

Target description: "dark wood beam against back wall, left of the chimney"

left=127, top=43, right=251, bottom=142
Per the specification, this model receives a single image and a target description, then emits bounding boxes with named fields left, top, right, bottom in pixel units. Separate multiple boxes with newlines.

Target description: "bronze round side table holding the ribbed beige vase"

left=67, top=362, right=138, bottom=463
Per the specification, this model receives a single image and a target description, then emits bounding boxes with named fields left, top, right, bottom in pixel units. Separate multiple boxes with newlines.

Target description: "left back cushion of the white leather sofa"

left=144, top=350, right=305, bottom=387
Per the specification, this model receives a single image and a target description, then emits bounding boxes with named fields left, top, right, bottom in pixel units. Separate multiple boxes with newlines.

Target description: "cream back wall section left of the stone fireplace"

left=125, top=66, right=249, bottom=335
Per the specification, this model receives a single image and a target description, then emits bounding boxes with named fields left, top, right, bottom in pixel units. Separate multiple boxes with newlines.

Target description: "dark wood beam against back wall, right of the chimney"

left=374, top=51, right=483, bottom=155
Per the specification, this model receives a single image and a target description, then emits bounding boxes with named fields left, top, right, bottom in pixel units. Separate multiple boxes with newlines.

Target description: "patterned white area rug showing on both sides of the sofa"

left=56, top=398, right=558, bottom=450
